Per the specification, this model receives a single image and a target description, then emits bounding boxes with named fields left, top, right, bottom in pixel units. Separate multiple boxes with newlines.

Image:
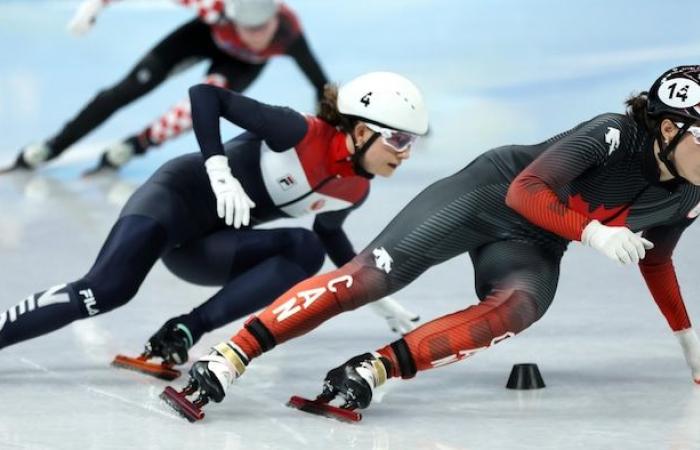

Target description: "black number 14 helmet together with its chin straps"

left=647, top=65, right=700, bottom=178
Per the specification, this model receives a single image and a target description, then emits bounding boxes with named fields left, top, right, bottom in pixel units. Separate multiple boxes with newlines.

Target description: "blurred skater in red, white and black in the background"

left=0, top=0, right=328, bottom=173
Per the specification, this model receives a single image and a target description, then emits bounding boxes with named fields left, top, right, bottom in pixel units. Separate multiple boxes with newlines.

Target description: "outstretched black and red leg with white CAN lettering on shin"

left=226, top=165, right=504, bottom=357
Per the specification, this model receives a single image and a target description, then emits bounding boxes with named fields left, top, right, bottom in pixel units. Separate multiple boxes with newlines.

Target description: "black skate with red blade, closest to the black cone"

left=287, top=353, right=391, bottom=422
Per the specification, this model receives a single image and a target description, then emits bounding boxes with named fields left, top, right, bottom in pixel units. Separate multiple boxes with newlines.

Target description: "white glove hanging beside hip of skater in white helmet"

left=204, top=155, right=255, bottom=228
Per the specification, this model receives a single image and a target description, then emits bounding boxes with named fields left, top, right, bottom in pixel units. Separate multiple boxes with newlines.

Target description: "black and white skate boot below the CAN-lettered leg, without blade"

left=190, top=341, right=248, bottom=403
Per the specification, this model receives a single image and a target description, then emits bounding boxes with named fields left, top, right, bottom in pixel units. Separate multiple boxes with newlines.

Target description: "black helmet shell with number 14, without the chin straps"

left=647, top=66, right=700, bottom=122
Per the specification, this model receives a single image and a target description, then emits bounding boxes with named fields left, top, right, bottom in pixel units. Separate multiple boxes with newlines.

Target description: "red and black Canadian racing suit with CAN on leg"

left=232, top=114, right=700, bottom=378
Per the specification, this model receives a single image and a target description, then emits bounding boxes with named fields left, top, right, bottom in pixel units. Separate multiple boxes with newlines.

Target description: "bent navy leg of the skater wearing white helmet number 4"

left=151, top=228, right=325, bottom=361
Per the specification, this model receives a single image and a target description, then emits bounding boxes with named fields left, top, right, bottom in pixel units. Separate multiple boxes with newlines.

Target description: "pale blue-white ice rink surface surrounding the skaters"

left=0, top=0, right=700, bottom=450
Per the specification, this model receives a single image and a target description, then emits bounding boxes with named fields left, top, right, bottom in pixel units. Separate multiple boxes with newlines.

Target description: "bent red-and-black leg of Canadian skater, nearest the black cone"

left=379, top=241, right=561, bottom=378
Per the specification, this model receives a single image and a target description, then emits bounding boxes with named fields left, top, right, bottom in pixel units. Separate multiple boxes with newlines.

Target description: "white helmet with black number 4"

left=338, top=72, right=428, bottom=135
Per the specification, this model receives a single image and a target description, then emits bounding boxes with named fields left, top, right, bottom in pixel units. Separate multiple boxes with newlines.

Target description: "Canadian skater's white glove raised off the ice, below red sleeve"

left=581, top=220, right=654, bottom=264
